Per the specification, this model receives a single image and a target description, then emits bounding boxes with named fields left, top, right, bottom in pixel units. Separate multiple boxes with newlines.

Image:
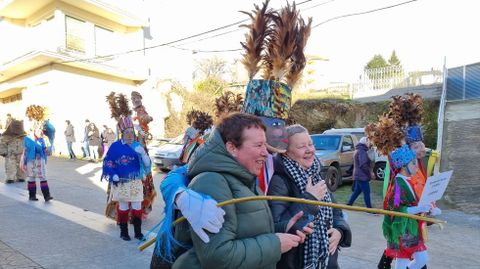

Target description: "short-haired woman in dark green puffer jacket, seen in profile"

left=173, top=113, right=311, bottom=269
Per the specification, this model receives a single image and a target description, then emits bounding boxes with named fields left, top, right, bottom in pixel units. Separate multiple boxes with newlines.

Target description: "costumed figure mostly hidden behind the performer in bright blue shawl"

left=131, top=91, right=157, bottom=219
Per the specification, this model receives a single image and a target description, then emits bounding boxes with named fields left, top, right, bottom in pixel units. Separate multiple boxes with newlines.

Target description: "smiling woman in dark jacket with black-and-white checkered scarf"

left=267, top=124, right=352, bottom=269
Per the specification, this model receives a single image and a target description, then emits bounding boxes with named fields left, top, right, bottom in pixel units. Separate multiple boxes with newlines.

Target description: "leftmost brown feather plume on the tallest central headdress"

left=240, top=0, right=271, bottom=79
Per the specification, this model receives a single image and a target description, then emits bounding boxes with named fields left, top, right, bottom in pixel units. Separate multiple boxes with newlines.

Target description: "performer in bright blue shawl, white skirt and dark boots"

left=102, top=92, right=151, bottom=241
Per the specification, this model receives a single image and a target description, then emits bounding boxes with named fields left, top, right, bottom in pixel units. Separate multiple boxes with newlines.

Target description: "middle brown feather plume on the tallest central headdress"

left=264, top=3, right=298, bottom=81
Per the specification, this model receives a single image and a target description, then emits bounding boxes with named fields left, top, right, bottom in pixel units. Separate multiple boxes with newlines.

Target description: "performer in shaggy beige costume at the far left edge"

left=0, top=119, right=26, bottom=184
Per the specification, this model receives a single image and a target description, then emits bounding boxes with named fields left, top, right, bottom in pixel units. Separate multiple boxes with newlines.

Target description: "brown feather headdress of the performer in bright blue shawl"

left=107, top=92, right=133, bottom=132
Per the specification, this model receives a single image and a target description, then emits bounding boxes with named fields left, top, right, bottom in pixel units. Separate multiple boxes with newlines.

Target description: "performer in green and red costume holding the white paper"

left=365, top=116, right=432, bottom=268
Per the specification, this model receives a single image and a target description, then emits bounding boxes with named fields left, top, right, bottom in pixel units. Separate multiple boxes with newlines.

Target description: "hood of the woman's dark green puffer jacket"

left=188, top=130, right=257, bottom=186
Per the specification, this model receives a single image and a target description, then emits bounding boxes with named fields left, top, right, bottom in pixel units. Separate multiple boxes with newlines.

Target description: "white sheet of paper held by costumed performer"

left=418, top=170, right=453, bottom=205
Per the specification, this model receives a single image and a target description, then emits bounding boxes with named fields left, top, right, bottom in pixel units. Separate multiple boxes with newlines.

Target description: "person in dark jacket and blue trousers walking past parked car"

left=347, top=137, right=372, bottom=208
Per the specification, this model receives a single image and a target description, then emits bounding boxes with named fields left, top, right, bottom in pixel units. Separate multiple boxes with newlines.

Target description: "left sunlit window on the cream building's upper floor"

left=65, top=16, right=88, bottom=52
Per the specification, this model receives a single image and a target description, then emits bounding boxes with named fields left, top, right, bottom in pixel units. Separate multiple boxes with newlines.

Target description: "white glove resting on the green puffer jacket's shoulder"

left=176, top=189, right=225, bottom=243
